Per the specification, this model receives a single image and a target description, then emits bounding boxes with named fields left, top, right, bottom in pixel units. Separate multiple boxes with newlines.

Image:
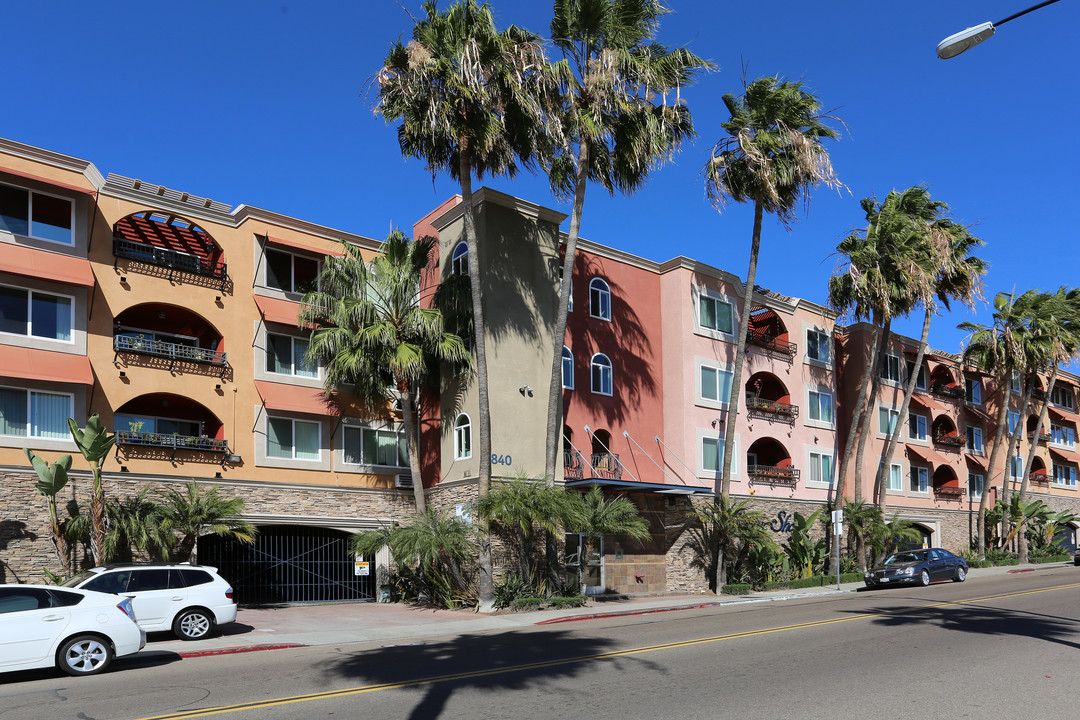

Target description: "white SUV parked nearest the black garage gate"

left=64, top=562, right=237, bottom=640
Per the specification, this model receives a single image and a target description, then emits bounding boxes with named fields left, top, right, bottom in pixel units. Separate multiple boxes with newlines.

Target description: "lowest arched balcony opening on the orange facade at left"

left=112, top=393, right=229, bottom=463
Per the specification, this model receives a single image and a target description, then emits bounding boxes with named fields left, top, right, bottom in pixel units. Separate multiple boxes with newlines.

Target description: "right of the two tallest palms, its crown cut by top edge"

left=544, top=0, right=713, bottom=485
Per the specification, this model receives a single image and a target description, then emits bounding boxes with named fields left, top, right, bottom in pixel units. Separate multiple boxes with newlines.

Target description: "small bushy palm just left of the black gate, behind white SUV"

left=160, top=480, right=257, bottom=562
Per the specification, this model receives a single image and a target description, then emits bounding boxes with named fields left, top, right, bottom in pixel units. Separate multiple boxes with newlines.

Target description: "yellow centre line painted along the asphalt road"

left=140, top=583, right=1080, bottom=720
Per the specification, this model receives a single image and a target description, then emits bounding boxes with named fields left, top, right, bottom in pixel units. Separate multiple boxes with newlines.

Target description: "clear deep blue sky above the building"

left=6, top=0, right=1080, bottom=352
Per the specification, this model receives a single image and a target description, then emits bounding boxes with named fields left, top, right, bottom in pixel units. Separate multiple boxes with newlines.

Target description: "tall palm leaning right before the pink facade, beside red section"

left=704, top=78, right=842, bottom=507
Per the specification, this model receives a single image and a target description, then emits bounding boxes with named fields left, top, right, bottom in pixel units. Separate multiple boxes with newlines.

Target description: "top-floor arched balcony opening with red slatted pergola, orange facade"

left=112, top=210, right=227, bottom=281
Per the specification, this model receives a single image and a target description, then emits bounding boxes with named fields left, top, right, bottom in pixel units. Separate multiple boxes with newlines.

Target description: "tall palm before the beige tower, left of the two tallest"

left=375, top=0, right=554, bottom=609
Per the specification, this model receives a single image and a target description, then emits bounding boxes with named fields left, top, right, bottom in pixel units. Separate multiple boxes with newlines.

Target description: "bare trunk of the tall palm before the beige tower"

left=458, top=143, right=495, bottom=611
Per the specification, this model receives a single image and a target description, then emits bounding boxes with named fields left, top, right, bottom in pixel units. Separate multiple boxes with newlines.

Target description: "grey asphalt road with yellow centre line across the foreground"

left=0, top=567, right=1080, bottom=720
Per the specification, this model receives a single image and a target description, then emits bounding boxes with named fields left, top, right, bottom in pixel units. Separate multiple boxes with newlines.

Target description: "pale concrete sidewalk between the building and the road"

left=143, top=563, right=1062, bottom=657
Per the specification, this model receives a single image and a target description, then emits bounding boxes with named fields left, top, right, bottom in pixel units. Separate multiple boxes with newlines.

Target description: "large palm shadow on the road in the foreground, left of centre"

left=323, top=630, right=663, bottom=719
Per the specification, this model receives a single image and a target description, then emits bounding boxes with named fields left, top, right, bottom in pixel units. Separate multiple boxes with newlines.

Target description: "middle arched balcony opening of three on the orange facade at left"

left=112, top=302, right=229, bottom=378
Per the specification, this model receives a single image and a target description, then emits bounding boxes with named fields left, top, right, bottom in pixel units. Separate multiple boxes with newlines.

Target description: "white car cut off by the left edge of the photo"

left=0, top=585, right=146, bottom=676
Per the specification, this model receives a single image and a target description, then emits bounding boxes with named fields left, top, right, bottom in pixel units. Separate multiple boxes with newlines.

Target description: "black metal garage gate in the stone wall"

left=198, top=526, right=375, bottom=604
